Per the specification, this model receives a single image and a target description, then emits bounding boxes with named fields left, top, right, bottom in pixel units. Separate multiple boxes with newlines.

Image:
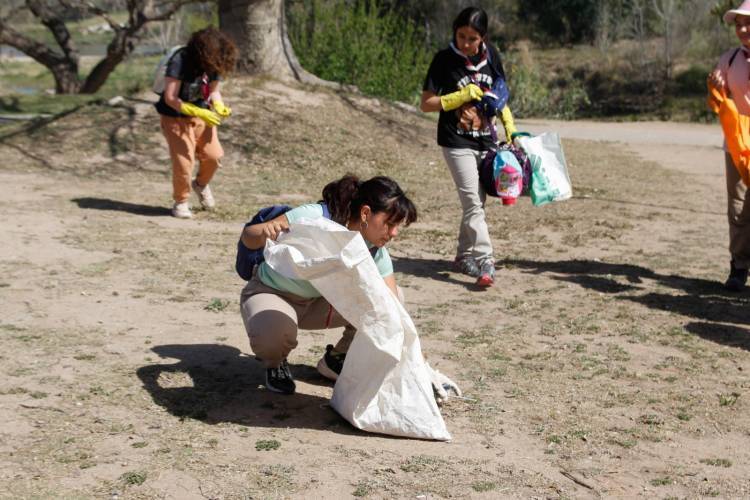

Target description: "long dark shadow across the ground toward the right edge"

left=506, top=259, right=750, bottom=349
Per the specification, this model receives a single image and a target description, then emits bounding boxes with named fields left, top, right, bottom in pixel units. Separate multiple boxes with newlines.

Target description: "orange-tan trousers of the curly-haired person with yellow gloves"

left=161, top=115, right=224, bottom=203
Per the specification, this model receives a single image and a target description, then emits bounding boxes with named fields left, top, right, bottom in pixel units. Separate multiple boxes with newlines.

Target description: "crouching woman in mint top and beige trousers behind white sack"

left=240, top=175, right=417, bottom=394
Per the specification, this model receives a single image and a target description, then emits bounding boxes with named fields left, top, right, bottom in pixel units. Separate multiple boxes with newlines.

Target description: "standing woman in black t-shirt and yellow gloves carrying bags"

left=420, top=7, right=516, bottom=287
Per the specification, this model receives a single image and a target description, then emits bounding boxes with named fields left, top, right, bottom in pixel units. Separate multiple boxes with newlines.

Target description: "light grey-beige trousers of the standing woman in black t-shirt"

left=443, top=148, right=492, bottom=261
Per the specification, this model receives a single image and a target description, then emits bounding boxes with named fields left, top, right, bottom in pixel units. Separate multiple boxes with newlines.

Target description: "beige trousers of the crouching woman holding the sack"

left=240, top=274, right=404, bottom=368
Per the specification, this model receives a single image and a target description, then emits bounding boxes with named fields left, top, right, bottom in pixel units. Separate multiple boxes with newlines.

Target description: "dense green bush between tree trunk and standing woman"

left=288, top=0, right=430, bottom=103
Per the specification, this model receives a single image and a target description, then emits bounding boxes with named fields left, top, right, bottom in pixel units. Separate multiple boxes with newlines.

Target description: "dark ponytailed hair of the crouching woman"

left=323, top=174, right=417, bottom=226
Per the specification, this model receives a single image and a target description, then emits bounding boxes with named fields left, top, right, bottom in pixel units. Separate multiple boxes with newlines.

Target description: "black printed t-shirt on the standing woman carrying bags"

left=422, top=44, right=505, bottom=151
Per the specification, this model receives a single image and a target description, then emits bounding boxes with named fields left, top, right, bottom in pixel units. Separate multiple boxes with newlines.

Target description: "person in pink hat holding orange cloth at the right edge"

left=708, top=0, right=750, bottom=292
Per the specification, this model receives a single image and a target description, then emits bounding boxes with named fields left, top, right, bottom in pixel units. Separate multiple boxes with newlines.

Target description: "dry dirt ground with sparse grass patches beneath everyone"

left=0, top=80, right=750, bottom=499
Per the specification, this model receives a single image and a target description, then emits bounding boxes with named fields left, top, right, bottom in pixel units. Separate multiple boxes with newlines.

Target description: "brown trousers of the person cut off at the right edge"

left=724, top=154, right=750, bottom=269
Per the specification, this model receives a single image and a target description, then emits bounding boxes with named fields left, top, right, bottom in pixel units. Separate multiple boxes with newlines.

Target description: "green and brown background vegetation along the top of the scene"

left=0, top=0, right=748, bottom=121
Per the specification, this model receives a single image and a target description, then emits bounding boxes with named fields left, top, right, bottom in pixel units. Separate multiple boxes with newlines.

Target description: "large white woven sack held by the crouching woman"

left=264, top=219, right=451, bottom=441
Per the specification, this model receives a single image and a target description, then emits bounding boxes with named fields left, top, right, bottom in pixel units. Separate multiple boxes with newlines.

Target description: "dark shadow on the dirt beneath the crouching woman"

left=136, top=344, right=365, bottom=435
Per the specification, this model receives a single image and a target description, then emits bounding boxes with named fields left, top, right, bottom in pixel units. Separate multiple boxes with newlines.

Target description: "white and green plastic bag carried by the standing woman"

left=515, top=132, right=573, bottom=206
